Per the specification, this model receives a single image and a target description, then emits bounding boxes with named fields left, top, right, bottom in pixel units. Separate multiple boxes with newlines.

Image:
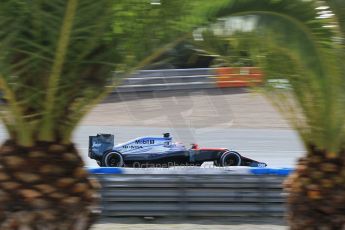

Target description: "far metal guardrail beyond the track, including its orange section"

left=115, top=67, right=262, bottom=93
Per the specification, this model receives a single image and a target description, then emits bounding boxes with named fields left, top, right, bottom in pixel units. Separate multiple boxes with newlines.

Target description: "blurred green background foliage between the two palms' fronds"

left=113, top=0, right=198, bottom=71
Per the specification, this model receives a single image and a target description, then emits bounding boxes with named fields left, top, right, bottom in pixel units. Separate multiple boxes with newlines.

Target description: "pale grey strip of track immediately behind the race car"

left=74, top=125, right=304, bottom=167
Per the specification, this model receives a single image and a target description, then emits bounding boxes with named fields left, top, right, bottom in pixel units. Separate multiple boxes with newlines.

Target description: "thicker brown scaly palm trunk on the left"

left=0, top=141, right=97, bottom=230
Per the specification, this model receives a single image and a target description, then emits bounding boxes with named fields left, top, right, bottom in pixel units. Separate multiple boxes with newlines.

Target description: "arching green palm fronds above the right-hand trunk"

left=192, top=0, right=345, bottom=151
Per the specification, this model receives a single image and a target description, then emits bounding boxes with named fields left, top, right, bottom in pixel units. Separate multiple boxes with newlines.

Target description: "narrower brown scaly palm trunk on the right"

left=285, top=146, right=345, bottom=230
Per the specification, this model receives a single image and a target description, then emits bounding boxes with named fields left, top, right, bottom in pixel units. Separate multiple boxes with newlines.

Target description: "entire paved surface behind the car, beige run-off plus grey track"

left=0, top=89, right=305, bottom=167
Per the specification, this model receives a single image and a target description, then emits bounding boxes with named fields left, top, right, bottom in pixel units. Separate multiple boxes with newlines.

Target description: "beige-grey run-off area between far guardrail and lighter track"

left=83, top=89, right=290, bottom=129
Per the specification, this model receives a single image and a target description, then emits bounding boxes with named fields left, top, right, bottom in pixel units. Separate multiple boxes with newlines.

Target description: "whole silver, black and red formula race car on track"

left=89, top=133, right=267, bottom=168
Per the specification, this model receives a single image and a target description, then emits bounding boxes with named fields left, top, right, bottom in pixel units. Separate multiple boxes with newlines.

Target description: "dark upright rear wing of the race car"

left=89, top=134, right=114, bottom=159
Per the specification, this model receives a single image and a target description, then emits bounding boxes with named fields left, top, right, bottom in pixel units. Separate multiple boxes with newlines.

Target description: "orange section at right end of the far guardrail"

left=216, top=67, right=263, bottom=88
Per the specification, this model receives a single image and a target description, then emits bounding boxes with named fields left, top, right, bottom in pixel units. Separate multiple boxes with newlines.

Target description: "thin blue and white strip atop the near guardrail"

left=88, top=166, right=294, bottom=176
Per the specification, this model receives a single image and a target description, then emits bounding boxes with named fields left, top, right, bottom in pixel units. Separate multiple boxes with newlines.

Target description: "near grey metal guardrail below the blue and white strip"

left=95, top=174, right=286, bottom=218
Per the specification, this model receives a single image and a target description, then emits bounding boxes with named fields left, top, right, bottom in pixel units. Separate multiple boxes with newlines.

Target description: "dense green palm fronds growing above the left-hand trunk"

left=0, top=0, right=115, bottom=145
